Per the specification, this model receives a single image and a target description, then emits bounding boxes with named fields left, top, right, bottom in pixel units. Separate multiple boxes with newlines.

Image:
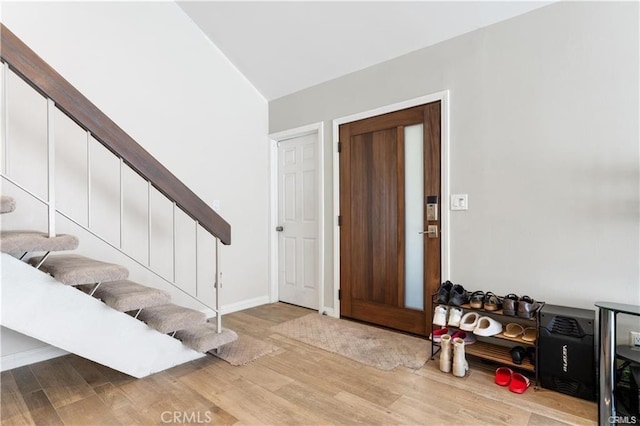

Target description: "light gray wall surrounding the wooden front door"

left=269, top=2, right=640, bottom=316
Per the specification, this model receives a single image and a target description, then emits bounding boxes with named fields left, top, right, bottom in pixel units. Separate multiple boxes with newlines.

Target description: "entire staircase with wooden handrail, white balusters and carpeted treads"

left=0, top=23, right=237, bottom=377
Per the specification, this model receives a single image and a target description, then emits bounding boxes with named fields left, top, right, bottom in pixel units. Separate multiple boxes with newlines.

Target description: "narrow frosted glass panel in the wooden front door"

left=404, top=124, right=426, bottom=310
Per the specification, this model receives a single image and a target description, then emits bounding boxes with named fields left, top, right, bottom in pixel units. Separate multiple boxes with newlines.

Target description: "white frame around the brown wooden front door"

left=331, top=90, right=451, bottom=318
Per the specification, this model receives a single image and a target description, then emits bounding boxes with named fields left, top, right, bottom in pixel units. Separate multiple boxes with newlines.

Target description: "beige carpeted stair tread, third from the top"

left=29, top=254, right=129, bottom=285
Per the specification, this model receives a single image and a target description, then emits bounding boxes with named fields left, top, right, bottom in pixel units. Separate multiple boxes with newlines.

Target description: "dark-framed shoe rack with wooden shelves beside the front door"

left=431, top=302, right=538, bottom=382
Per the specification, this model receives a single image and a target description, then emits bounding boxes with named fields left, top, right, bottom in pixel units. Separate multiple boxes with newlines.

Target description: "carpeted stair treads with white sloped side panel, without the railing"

left=0, top=196, right=237, bottom=377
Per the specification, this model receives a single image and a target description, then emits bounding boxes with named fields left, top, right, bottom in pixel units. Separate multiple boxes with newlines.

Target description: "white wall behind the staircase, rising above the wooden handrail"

left=1, top=2, right=269, bottom=362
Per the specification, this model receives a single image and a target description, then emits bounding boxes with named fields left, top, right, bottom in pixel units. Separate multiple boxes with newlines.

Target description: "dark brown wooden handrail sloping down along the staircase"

left=0, top=23, right=231, bottom=245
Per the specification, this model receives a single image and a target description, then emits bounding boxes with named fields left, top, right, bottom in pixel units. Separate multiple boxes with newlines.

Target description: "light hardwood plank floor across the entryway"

left=1, top=303, right=597, bottom=426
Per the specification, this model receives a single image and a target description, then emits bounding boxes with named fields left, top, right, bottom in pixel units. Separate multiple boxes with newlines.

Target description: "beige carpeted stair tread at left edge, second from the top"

left=0, top=231, right=79, bottom=253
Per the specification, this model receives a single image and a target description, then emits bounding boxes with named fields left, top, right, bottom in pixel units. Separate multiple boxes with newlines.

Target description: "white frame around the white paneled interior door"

left=269, top=121, right=325, bottom=313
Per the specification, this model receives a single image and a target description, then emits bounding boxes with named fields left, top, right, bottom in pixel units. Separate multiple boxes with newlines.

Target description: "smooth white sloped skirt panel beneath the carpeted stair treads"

left=1, top=253, right=205, bottom=378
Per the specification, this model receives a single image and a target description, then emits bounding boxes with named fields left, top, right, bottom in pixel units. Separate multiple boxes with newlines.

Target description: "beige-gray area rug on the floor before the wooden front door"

left=271, top=314, right=431, bottom=370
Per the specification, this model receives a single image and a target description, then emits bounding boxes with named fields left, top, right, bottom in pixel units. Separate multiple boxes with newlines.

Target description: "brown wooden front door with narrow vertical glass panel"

left=339, top=102, right=441, bottom=335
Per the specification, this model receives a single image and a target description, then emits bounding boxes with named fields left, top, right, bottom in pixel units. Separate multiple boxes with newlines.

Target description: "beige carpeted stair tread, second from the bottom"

left=138, top=303, right=207, bottom=333
